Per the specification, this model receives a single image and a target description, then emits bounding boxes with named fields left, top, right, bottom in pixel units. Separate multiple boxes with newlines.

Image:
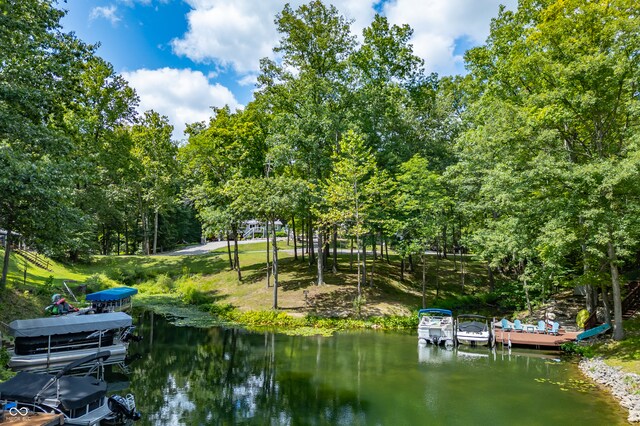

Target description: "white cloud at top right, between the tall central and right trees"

left=384, top=0, right=517, bottom=75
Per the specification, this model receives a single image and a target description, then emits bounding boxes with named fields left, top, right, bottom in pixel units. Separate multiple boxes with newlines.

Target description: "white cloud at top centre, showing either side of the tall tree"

left=171, top=0, right=376, bottom=74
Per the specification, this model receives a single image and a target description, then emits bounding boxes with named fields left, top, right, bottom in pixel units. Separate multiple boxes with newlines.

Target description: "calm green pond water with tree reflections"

left=120, top=313, right=626, bottom=426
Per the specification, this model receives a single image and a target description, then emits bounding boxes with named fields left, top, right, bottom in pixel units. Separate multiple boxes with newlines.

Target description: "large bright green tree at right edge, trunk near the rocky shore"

left=459, top=0, right=640, bottom=339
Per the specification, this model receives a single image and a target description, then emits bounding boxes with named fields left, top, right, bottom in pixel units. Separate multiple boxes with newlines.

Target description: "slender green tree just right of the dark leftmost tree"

left=65, top=58, right=138, bottom=257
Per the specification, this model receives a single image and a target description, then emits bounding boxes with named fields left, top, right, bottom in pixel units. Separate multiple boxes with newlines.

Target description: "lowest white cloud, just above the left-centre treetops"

left=122, top=68, right=241, bottom=140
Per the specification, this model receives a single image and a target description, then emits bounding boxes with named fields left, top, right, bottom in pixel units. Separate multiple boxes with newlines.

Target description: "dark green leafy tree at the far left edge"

left=0, top=0, right=93, bottom=288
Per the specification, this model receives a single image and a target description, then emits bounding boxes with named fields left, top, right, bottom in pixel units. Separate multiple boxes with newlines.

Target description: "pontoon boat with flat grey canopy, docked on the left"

left=8, top=312, right=134, bottom=371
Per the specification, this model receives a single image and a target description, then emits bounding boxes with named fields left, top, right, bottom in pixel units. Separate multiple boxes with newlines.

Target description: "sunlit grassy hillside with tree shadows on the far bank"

left=0, top=242, right=486, bottom=322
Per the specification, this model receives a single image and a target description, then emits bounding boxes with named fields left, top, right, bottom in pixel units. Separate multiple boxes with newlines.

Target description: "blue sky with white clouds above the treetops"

left=59, top=0, right=516, bottom=139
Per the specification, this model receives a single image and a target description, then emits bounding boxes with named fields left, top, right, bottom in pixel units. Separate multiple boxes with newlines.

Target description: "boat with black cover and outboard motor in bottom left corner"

left=0, top=351, right=140, bottom=426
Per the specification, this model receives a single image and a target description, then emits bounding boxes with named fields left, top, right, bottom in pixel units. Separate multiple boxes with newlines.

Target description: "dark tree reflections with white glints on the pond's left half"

left=130, top=312, right=365, bottom=425
